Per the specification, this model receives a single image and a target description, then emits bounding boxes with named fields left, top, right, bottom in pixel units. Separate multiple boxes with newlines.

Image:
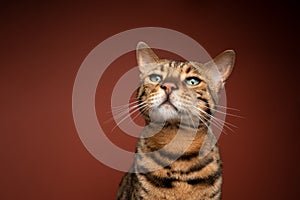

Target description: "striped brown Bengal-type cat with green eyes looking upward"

left=117, top=42, right=235, bottom=200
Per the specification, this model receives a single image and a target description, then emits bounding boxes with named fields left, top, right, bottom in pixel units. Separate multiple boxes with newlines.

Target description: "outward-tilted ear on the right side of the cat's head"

left=207, top=50, right=235, bottom=82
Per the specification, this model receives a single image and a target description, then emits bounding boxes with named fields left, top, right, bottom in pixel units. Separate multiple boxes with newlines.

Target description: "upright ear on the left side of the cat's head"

left=136, top=42, right=159, bottom=73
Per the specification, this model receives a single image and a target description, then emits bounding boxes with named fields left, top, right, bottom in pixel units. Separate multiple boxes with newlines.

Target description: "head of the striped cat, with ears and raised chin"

left=136, top=42, right=235, bottom=123
